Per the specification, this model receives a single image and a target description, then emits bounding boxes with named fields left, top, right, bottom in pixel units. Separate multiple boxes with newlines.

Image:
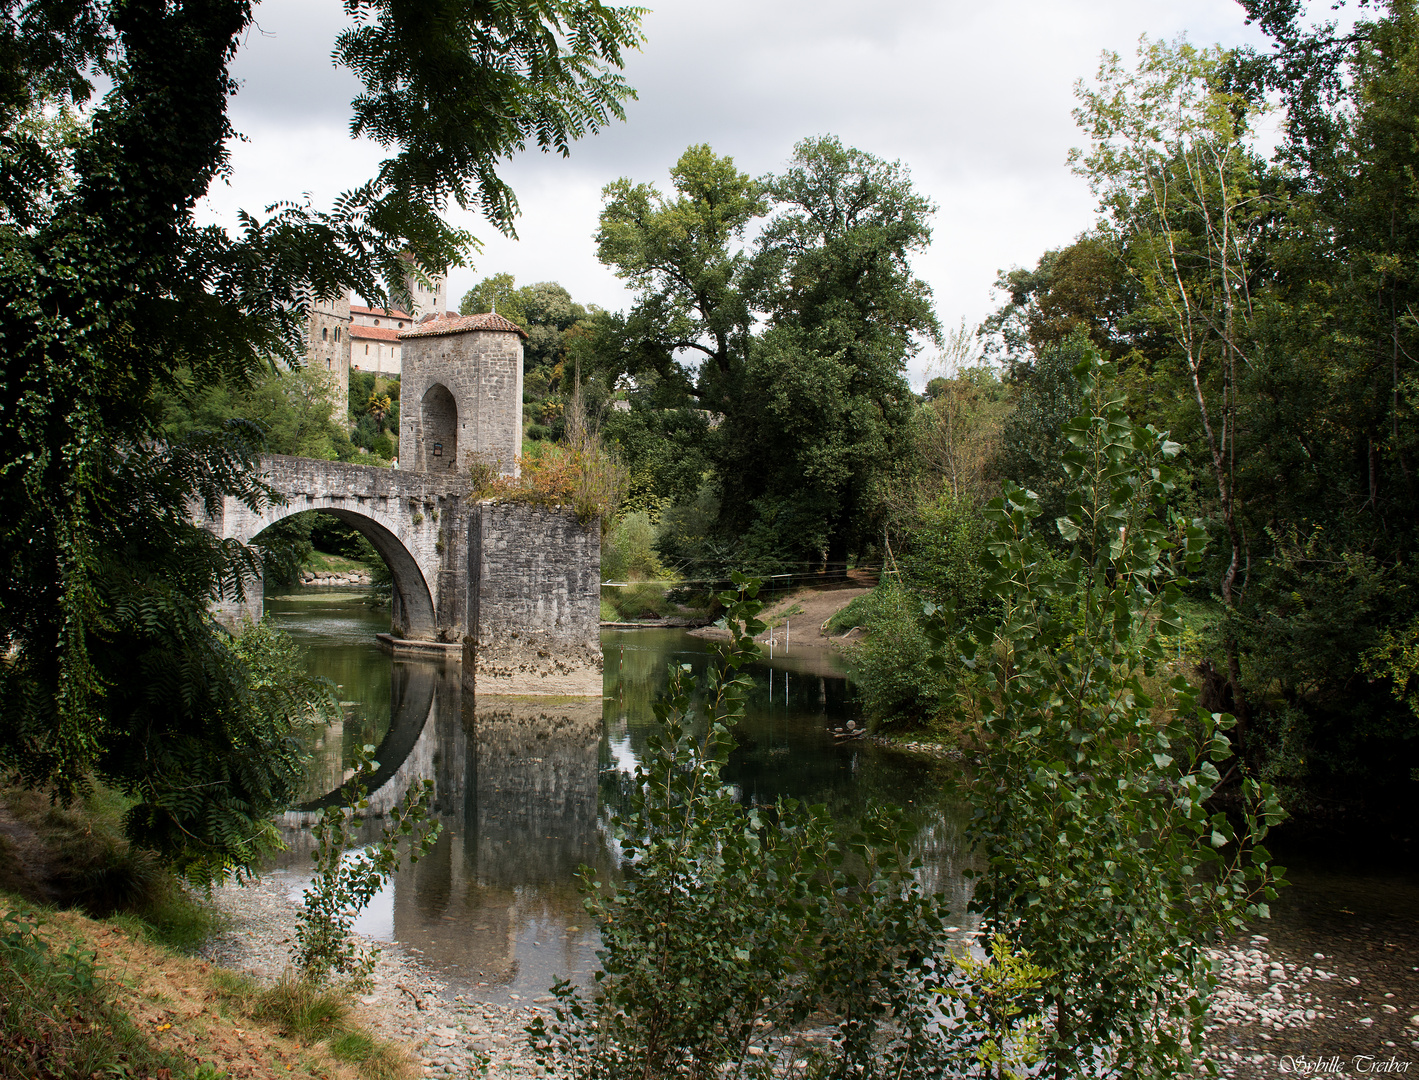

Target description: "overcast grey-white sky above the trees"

left=209, top=0, right=1294, bottom=386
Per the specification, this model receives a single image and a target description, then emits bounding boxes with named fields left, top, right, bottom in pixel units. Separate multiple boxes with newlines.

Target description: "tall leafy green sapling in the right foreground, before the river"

left=938, top=351, right=1283, bottom=1077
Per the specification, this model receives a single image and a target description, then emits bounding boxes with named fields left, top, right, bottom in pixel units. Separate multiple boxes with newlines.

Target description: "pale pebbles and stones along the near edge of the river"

left=204, top=877, right=1419, bottom=1080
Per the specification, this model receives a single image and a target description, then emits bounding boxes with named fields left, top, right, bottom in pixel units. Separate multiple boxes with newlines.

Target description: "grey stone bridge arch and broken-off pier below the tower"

left=207, top=456, right=600, bottom=695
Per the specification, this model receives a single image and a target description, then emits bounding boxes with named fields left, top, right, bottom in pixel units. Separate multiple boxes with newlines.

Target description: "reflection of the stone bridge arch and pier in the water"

left=281, top=660, right=606, bottom=986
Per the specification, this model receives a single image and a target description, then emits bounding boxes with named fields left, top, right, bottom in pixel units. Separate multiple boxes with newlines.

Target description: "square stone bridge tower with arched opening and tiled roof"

left=399, top=312, right=528, bottom=478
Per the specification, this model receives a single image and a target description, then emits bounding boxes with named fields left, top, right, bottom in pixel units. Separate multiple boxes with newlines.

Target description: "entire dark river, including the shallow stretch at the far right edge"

left=258, top=590, right=1419, bottom=1076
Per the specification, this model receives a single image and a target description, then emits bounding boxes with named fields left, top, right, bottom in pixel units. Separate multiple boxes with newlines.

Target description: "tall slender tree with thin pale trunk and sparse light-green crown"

left=1073, top=40, right=1277, bottom=727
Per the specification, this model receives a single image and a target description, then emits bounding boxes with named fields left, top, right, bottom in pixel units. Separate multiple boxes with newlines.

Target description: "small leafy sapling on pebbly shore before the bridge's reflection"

left=291, top=745, right=443, bottom=986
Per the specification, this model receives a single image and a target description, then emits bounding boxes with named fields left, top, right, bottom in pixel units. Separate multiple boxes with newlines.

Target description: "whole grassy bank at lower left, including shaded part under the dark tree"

left=0, top=785, right=416, bottom=1080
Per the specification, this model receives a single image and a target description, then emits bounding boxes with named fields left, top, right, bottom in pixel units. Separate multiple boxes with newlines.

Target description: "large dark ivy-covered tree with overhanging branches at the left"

left=0, top=0, right=639, bottom=873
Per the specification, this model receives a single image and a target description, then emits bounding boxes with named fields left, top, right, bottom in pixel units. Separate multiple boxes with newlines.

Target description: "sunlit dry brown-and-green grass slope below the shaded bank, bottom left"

left=0, top=896, right=416, bottom=1080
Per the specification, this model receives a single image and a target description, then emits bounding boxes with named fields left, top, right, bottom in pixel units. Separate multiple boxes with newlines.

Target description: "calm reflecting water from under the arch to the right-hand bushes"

left=267, top=590, right=973, bottom=1002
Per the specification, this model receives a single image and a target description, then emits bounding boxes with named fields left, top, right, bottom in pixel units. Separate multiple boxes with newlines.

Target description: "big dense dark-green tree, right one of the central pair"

left=715, top=138, right=941, bottom=566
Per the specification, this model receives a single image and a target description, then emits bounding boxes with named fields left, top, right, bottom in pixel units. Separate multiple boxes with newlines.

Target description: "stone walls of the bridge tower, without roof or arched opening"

left=399, top=329, right=522, bottom=477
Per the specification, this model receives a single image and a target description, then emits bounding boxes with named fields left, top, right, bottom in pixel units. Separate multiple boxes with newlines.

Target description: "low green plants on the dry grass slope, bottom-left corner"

left=0, top=907, right=189, bottom=1080
